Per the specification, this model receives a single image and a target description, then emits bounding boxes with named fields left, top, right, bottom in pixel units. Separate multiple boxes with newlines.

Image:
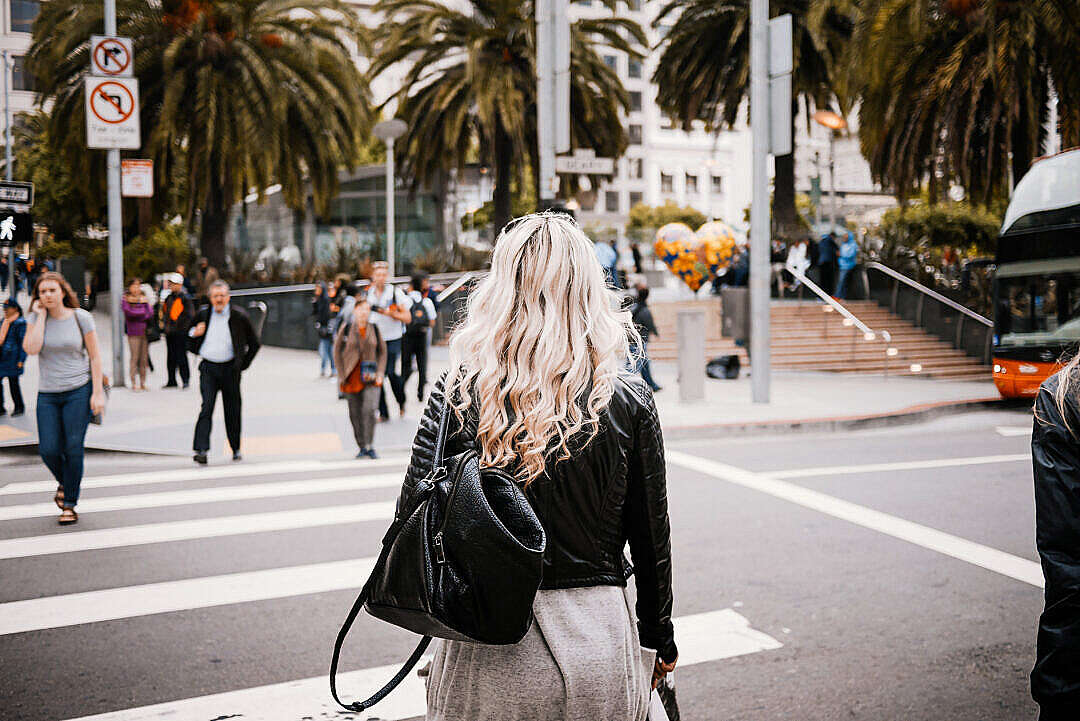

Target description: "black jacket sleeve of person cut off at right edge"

left=1031, top=377, right=1080, bottom=721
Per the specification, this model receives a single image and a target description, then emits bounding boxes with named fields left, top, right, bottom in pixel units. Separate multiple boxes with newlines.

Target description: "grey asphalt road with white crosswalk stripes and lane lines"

left=0, top=411, right=1042, bottom=721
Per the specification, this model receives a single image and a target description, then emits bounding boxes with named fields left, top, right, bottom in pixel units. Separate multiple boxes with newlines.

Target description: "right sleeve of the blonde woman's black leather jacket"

left=623, top=379, right=678, bottom=663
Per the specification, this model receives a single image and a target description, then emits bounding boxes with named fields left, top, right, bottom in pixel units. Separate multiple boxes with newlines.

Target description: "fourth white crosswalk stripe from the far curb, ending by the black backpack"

left=0, top=558, right=375, bottom=636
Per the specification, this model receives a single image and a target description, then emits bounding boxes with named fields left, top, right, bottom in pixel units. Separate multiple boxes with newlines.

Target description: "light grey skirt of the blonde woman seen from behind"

left=427, top=586, right=656, bottom=721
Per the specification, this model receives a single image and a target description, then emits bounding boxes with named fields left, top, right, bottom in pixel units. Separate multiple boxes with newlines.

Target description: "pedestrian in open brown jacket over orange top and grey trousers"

left=334, top=298, right=387, bottom=459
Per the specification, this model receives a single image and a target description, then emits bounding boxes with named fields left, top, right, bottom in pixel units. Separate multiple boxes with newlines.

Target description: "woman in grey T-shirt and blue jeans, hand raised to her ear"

left=23, top=272, right=105, bottom=526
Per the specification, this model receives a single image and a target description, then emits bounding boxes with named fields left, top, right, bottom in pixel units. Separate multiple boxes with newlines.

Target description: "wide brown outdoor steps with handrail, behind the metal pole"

left=649, top=298, right=990, bottom=380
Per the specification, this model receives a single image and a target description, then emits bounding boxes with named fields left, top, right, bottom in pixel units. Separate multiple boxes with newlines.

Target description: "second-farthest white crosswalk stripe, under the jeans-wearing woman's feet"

left=0, top=473, right=402, bottom=520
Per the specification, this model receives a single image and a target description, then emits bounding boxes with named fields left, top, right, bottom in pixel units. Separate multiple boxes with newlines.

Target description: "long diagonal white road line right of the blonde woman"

left=665, top=451, right=1042, bottom=588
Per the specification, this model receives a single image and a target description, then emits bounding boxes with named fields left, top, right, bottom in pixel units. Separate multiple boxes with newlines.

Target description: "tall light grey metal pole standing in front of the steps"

left=750, top=0, right=772, bottom=403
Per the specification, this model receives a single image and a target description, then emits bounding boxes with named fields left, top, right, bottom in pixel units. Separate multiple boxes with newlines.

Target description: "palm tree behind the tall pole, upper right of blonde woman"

left=652, top=0, right=853, bottom=235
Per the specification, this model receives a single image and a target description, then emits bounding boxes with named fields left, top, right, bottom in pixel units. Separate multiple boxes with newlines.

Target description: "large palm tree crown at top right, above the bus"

left=856, top=0, right=1080, bottom=203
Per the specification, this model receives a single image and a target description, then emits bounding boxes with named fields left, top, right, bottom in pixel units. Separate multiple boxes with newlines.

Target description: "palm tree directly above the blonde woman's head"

left=369, top=0, right=646, bottom=230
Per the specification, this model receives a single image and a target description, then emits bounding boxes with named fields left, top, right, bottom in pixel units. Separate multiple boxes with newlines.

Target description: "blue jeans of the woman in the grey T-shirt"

left=38, top=382, right=93, bottom=508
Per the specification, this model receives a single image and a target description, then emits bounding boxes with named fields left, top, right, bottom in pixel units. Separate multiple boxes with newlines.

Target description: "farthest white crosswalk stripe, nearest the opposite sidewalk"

left=0, top=455, right=409, bottom=495
